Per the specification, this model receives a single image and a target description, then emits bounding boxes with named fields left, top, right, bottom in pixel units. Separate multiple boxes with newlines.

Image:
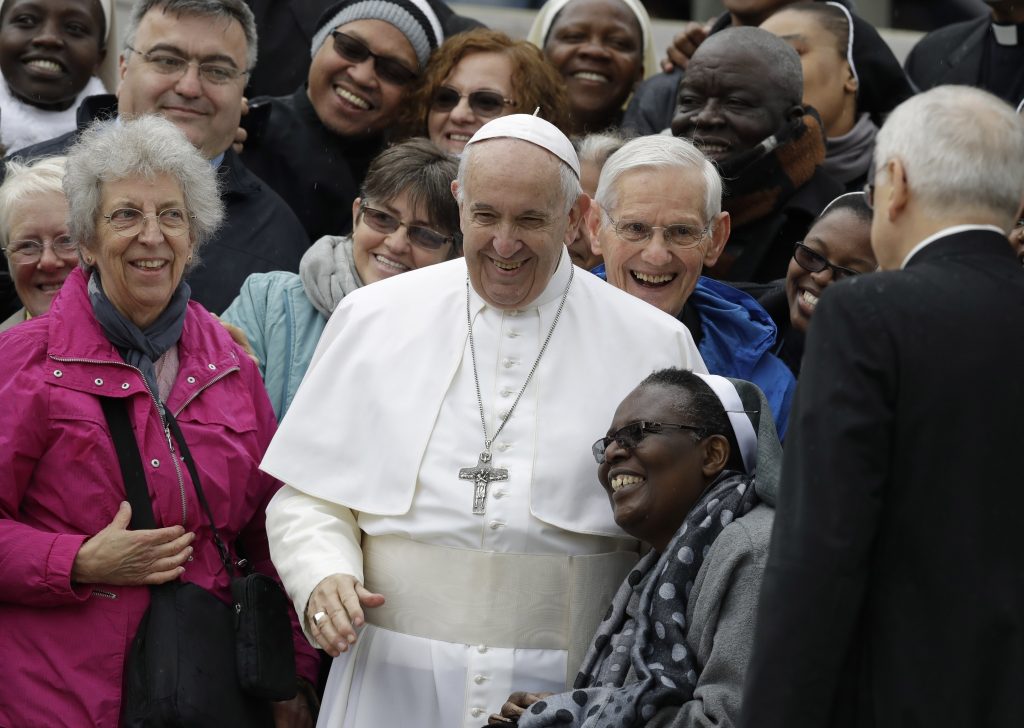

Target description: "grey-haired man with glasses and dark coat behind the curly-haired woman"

left=3, top=0, right=308, bottom=313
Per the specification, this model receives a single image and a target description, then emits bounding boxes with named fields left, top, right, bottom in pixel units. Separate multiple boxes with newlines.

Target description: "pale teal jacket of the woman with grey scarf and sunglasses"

left=220, top=270, right=327, bottom=422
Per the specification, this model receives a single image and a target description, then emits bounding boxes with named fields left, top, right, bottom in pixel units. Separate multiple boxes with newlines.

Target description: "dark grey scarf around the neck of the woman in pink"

left=89, top=270, right=191, bottom=403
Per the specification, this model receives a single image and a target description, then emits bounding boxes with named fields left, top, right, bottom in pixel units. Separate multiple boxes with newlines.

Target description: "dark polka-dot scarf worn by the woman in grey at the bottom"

left=519, top=471, right=760, bottom=728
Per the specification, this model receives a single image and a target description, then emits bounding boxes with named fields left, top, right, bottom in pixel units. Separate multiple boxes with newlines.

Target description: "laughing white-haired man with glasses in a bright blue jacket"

left=590, top=135, right=796, bottom=436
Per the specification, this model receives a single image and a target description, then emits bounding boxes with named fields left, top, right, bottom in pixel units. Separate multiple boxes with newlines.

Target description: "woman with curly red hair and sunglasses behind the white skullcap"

left=402, top=28, right=568, bottom=155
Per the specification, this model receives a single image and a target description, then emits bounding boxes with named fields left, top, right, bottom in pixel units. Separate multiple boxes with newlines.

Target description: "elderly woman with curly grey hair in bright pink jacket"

left=0, top=117, right=316, bottom=728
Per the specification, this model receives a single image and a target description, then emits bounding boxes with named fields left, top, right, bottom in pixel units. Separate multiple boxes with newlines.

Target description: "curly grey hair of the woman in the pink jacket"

left=63, top=115, right=224, bottom=269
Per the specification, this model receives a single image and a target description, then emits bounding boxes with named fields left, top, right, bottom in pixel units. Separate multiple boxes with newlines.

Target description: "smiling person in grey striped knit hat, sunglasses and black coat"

left=242, top=0, right=444, bottom=246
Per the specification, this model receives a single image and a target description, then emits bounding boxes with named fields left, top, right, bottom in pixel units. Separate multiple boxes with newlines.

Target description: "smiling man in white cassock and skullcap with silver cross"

left=262, top=115, right=706, bottom=728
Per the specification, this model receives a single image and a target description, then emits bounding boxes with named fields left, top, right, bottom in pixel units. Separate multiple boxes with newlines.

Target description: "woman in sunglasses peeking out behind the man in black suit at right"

left=763, top=192, right=879, bottom=377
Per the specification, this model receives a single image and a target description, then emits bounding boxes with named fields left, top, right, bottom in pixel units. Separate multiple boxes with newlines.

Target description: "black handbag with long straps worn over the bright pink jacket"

left=101, top=398, right=297, bottom=728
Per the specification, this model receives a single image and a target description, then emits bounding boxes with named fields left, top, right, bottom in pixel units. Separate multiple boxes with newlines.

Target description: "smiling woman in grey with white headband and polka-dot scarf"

left=488, top=369, right=781, bottom=728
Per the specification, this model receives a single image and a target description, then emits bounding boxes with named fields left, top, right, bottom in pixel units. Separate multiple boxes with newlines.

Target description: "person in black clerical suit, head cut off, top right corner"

left=904, top=0, right=1024, bottom=106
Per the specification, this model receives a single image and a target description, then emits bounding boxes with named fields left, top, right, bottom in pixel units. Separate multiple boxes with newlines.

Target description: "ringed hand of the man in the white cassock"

left=306, top=573, right=384, bottom=657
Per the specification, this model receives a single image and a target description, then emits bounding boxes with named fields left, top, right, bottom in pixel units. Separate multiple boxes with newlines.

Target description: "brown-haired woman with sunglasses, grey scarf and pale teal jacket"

left=228, top=139, right=462, bottom=421
